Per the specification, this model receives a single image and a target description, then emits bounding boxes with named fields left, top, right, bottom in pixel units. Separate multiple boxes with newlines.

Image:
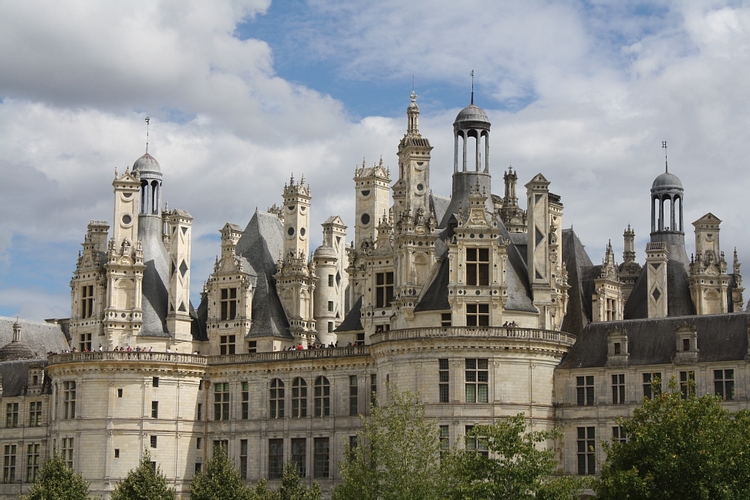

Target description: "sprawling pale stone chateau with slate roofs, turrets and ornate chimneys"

left=0, top=93, right=750, bottom=498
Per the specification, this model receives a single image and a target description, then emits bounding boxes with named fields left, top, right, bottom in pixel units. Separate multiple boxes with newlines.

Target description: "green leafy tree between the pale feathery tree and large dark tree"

left=446, top=414, right=584, bottom=500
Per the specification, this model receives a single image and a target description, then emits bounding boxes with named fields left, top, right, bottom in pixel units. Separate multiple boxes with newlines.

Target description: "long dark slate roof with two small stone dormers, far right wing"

left=558, top=313, right=750, bottom=369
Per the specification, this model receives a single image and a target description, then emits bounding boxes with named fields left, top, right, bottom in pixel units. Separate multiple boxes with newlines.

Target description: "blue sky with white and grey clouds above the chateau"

left=0, top=0, right=750, bottom=320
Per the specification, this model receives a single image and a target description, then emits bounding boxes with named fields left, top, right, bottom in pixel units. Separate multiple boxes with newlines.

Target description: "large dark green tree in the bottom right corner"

left=593, top=379, right=750, bottom=500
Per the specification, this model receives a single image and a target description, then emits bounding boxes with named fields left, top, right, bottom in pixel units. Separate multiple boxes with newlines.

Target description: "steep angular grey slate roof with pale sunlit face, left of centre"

left=235, top=210, right=293, bottom=339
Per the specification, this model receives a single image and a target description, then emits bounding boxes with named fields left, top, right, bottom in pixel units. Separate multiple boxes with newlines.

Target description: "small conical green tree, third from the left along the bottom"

left=190, top=446, right=252, bottom=500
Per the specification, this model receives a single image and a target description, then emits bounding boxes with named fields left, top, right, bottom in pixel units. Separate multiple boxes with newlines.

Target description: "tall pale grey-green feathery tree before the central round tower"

left=332, top=387, right=443, bottom=500
